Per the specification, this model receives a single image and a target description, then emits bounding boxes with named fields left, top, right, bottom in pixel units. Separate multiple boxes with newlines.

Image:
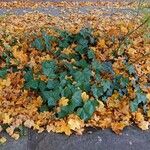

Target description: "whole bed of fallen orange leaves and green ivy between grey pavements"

left=0, top=1, right=150, bottom=143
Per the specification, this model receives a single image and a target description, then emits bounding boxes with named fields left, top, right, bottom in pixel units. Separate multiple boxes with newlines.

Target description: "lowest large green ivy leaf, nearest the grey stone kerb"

left=77, top=100, right=98, bottom=121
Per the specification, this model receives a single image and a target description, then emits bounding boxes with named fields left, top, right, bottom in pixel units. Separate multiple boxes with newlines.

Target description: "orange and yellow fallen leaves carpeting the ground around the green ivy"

left=0, top=1, right=150, bottom=141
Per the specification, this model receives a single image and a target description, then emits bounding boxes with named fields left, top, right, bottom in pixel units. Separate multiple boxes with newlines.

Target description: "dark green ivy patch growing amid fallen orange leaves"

left=22, top=28, right=146, bottom=121
